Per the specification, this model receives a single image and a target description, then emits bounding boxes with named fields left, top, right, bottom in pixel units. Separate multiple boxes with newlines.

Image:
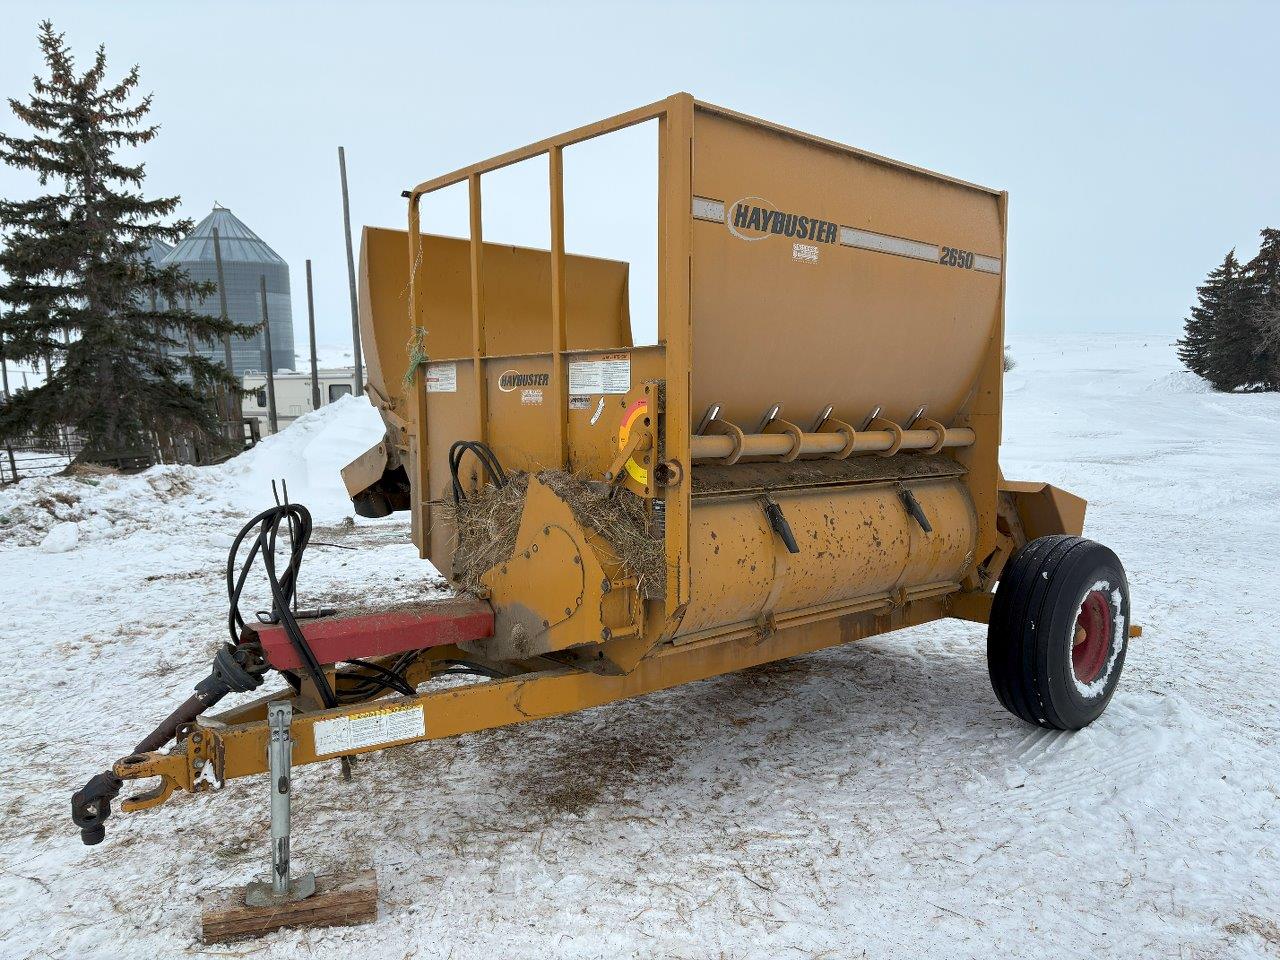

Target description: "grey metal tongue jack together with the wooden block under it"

left=201, top=700, right=378, bottom=943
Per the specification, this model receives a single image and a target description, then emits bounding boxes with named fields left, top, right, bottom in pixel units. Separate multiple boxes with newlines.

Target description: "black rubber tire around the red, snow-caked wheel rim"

left=987, top=536, right=1129, bottom=730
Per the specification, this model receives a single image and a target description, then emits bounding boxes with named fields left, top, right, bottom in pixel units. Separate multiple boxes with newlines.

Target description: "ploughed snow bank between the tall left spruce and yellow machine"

left=0, top=397, right=383, bottom=550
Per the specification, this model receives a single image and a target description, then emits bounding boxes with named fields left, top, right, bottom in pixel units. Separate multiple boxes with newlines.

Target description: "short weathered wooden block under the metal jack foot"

left=200, top=870, right=378, bottom=943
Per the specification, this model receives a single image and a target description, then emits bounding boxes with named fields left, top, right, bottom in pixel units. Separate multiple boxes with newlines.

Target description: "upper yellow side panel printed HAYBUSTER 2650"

left=691, top=111, right=1004, bottom=429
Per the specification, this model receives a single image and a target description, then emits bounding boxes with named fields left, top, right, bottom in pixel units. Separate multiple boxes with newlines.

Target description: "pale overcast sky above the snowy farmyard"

left=0, top=0, right=1280, bottom=349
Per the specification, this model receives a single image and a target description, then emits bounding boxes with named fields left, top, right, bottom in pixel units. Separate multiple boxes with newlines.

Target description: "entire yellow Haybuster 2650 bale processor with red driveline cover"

left=73, top=93, right=1129, bottom=872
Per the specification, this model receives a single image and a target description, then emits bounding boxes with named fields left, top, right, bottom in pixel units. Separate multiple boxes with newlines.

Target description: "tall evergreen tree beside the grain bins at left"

left=0, top=20, right=253, bottom=461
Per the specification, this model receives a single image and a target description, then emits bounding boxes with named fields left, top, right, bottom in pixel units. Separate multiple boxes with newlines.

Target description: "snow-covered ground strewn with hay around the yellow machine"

left=0, top=335, right=1280, bottom=960
